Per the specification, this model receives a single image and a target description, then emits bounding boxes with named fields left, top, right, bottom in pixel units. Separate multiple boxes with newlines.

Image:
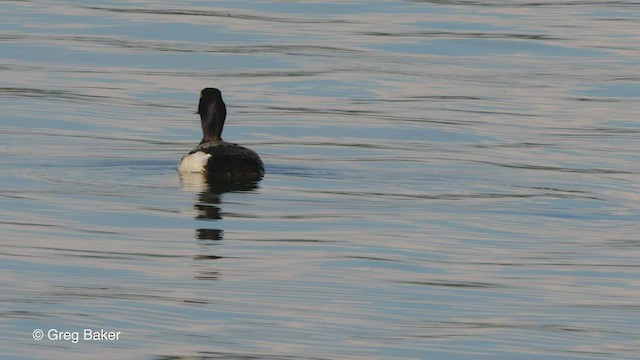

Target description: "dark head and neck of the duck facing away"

left=198, top=88, right=227, bottom=143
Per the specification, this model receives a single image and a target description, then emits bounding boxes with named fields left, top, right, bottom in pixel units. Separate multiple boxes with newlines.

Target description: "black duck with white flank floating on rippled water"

left=178, top=88, right=264, bottom=180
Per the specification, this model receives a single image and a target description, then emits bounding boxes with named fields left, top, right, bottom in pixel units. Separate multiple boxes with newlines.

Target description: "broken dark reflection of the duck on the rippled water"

left=180, top=173, right=259, bottom=280
